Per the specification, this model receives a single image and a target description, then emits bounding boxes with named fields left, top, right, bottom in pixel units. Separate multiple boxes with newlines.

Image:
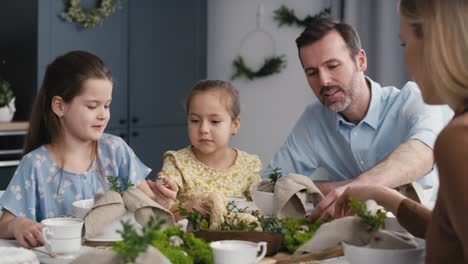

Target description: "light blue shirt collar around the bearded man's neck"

left=327, top=76, right=382, bottom=130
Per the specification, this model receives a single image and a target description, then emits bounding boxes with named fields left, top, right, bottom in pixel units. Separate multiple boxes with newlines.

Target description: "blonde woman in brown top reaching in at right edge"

left=335, top=0, right=468, bottom=263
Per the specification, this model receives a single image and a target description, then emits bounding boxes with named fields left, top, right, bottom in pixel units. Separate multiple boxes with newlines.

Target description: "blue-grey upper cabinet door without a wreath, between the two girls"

left=129, top=0, right=206, bottom=127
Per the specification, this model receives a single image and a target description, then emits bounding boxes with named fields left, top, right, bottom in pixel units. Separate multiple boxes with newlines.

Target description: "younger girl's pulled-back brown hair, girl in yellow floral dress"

left=185, top=80, right=240, bottom=120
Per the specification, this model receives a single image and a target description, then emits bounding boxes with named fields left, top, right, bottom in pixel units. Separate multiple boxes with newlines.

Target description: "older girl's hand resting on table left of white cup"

left=9, top=216, right=44, bottom=248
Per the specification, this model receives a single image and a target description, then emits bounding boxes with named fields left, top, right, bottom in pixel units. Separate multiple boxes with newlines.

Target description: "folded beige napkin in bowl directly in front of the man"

left=273, top=173, right=324, bottom=218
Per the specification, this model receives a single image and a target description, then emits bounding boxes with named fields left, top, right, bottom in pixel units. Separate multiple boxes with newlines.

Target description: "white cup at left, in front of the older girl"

left=41, top=218, right=83, bottom=256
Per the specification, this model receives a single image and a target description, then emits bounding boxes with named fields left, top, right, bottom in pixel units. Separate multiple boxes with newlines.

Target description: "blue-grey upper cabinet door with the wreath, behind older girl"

left=38, top=0, right=128, bottom=128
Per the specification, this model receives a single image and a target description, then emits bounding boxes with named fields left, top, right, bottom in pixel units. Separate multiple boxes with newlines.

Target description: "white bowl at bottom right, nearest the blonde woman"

left=342, top=239, right=425, bottom=264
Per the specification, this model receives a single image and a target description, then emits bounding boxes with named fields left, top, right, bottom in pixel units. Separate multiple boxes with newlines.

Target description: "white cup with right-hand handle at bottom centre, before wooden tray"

left=210, top=240, right=267, bottom=264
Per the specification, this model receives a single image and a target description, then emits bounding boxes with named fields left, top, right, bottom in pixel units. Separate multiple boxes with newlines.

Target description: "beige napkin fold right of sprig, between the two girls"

left=122, top=188, right=175, bottom=226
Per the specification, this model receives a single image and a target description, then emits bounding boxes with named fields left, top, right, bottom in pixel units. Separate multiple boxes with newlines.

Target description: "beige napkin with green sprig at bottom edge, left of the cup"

left=72, top=246, right=171, bottom=264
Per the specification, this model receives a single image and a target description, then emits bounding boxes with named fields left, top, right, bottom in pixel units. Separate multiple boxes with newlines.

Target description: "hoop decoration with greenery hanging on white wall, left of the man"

left=231, top=4, right=286, bottom=80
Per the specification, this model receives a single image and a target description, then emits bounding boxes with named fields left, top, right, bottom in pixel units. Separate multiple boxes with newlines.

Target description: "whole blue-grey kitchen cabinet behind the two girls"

left=37, top=0, right=206, bottom=175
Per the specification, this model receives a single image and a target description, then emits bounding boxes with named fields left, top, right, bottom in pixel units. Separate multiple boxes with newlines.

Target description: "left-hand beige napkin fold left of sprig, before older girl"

left=84, top=191, right=127, bottom=238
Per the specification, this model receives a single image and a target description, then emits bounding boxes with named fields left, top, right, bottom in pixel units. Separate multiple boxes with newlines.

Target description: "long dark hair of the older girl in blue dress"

left=23, top=51, right=113, bottom=193
